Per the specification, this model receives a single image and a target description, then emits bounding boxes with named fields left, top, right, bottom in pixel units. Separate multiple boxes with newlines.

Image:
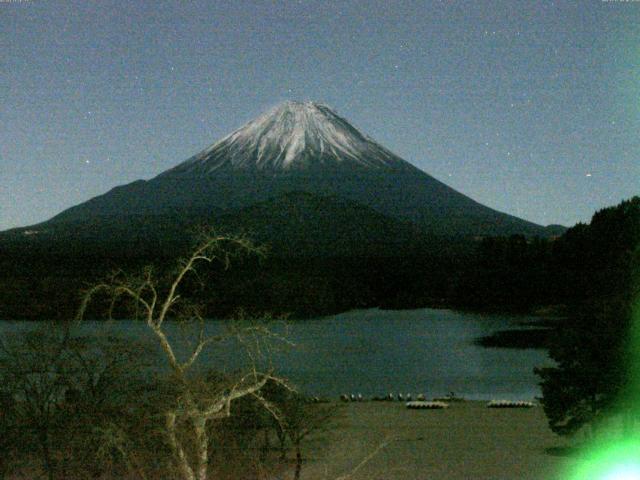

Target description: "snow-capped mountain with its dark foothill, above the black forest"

left=6, top=101, right=555, bottom=255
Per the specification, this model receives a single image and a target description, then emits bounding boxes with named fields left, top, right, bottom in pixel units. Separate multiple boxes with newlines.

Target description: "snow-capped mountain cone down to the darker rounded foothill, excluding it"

left=37, top=102, right=550, bottom=236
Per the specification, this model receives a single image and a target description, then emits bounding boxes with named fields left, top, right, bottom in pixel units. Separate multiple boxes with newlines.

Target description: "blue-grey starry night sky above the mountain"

left=0, top=0, right=640, bottom=230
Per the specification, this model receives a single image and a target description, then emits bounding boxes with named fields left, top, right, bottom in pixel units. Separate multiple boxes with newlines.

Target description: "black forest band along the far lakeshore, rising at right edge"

left=0, top=197, right=640, bottom=319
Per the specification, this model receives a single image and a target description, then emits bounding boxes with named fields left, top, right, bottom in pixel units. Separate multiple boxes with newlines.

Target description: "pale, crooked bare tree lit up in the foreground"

left=78, top=234, right=292, bottom=480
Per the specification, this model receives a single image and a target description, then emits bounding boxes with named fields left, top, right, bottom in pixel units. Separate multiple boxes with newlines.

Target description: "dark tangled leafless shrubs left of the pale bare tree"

left=0, top=325, right=150, bottom=479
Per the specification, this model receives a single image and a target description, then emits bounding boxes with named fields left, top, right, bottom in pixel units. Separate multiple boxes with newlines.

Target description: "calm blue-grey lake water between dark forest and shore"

left=0, top=309, right=553, bottom=400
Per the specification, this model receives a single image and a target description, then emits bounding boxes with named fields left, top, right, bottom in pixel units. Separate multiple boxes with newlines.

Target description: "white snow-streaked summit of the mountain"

left=162, top=101, right=413, bottom=176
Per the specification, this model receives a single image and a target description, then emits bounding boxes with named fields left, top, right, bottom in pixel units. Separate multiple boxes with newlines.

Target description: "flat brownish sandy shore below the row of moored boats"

left=302, top=401, right=574, bottom=480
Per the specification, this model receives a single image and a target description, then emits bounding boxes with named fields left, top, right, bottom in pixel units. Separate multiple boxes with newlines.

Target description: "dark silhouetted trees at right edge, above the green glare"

left=536, top=197, right=640, bottom=435
